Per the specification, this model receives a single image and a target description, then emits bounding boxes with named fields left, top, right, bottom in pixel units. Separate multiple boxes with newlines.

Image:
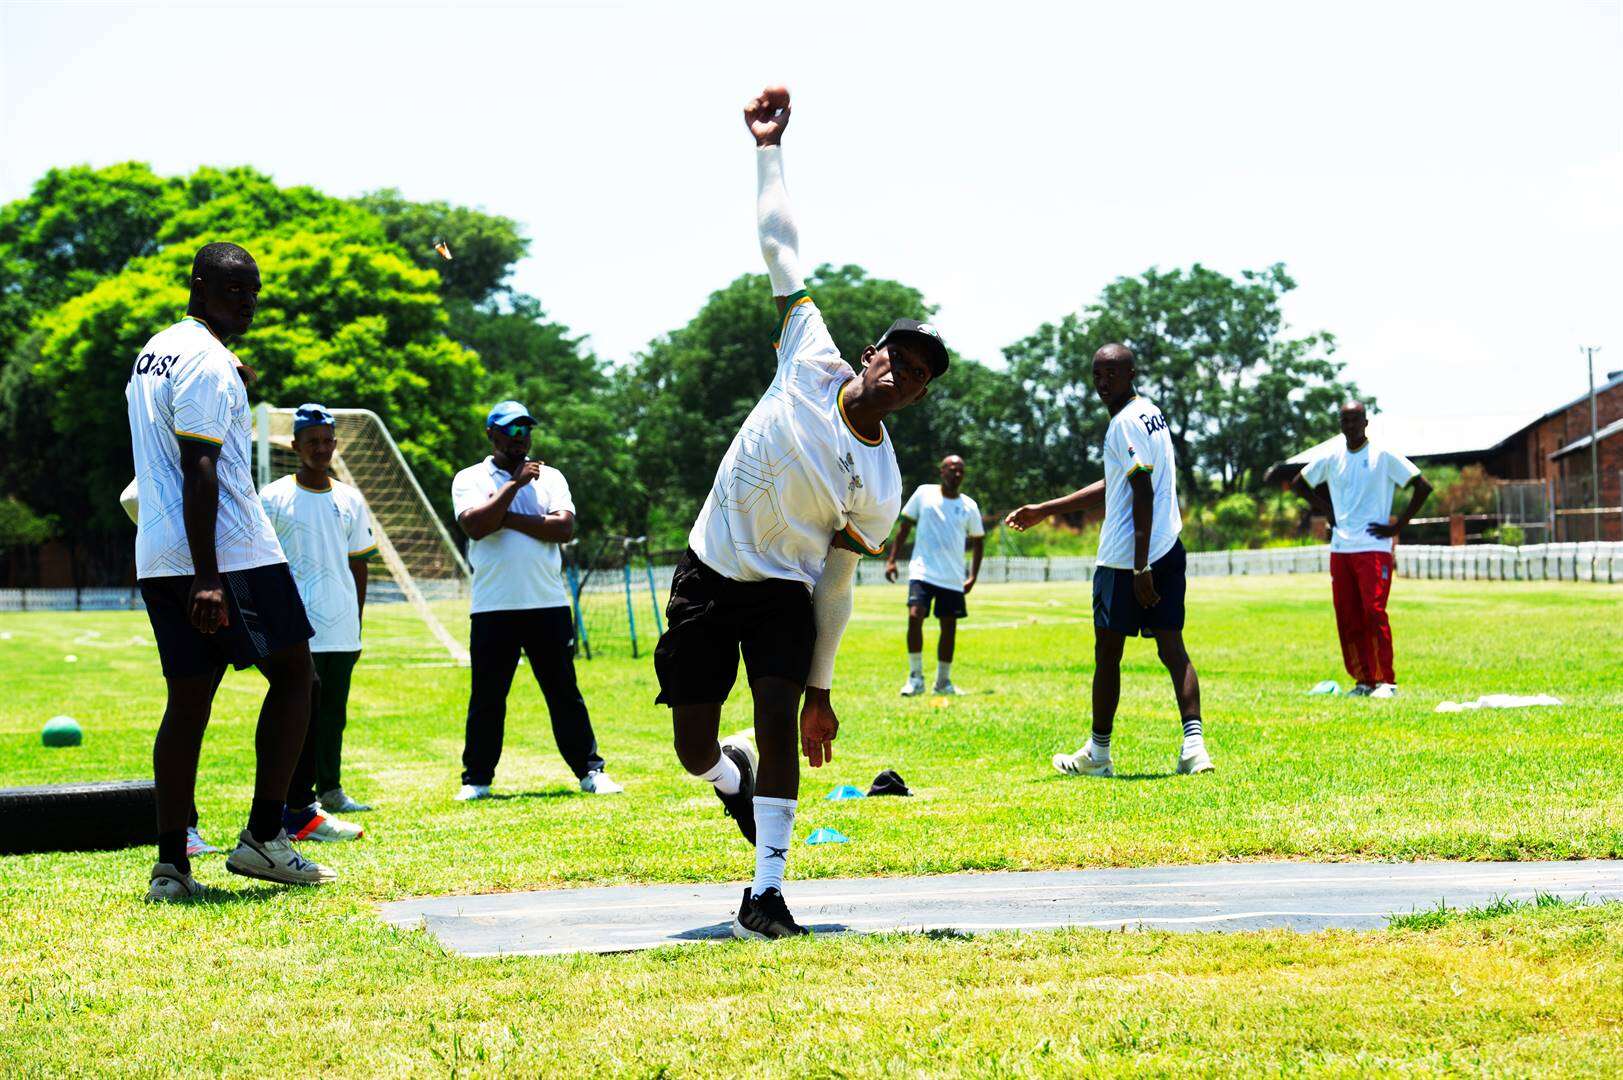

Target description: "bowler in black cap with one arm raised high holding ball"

left=654, top=86, right=948, bottom=939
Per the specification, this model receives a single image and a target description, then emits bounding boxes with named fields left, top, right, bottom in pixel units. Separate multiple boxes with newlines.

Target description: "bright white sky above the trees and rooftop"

left=0, top=0, right=1623, bottom=414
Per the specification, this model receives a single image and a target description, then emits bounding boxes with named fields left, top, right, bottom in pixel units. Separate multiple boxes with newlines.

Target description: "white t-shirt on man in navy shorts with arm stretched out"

left=1099, top=398, right=1183, bottom=570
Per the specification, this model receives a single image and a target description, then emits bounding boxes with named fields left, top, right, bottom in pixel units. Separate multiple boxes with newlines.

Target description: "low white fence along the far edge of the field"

left=0, top=542, right=1623, bottom=611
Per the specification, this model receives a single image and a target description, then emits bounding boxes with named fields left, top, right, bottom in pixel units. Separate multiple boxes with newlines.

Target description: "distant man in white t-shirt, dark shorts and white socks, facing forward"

left=885, top=453, right=987, bottom=697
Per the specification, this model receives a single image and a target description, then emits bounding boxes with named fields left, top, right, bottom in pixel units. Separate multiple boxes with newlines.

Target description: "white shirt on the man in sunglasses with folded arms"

left=451, top=458, right=575, bottom=616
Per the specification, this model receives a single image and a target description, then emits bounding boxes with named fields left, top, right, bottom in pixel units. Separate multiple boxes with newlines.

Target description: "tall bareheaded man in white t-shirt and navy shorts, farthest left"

left=125, top=244, right=338, bottom=900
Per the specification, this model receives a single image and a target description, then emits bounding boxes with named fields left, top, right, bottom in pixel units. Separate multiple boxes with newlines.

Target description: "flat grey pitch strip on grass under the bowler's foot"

left=381, top=861, right=1623, bottom=957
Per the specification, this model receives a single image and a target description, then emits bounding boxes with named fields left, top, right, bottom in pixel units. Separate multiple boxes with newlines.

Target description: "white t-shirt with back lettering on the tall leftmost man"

left=123, top=318, right=287, bottom=578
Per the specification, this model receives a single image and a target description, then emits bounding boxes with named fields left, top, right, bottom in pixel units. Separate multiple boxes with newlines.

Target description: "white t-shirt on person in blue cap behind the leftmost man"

left=260, top=476, right=378, bottom=653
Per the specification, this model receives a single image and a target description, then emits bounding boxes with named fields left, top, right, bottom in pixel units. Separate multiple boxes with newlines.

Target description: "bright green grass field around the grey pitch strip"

left=0, top=577, right=1623, bottom=1077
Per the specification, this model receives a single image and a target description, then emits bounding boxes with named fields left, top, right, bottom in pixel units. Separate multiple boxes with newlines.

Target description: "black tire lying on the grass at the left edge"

left=0, top=780, right=157, bottom=854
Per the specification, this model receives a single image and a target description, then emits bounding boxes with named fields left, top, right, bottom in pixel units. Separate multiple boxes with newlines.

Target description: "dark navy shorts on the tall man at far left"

left=141, top=562, right=315, bottom=679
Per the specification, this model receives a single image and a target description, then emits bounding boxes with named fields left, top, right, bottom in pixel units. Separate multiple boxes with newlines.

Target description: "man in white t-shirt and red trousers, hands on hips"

left=1290, top=401, right=1431, bottom=697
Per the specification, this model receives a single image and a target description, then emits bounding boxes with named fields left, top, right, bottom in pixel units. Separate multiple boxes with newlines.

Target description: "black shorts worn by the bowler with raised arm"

left=654, top=547, right=816, bottom=705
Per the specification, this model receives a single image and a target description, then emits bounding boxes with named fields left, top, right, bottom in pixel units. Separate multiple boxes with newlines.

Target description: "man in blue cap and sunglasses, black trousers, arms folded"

left=451, top=401, right=625, bottom=802
